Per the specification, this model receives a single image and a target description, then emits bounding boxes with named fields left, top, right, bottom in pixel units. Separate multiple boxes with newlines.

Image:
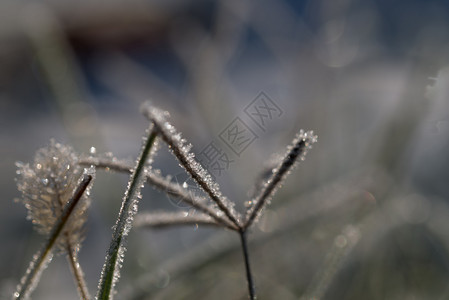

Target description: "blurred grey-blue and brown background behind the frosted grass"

left=0, top=0, right=449, bottom=299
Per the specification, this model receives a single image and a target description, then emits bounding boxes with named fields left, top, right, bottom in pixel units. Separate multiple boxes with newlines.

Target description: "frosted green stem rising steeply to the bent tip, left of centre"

left=97, top=126, right=157, bottom=300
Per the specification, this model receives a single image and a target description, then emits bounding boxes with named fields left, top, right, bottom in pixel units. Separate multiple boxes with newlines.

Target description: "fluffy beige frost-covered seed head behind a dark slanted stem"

left=16, top=140, right=93, bottom=251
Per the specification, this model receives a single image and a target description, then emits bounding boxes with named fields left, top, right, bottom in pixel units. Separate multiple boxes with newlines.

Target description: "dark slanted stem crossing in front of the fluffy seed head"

left=13, top=174, right=92, bottom=299
